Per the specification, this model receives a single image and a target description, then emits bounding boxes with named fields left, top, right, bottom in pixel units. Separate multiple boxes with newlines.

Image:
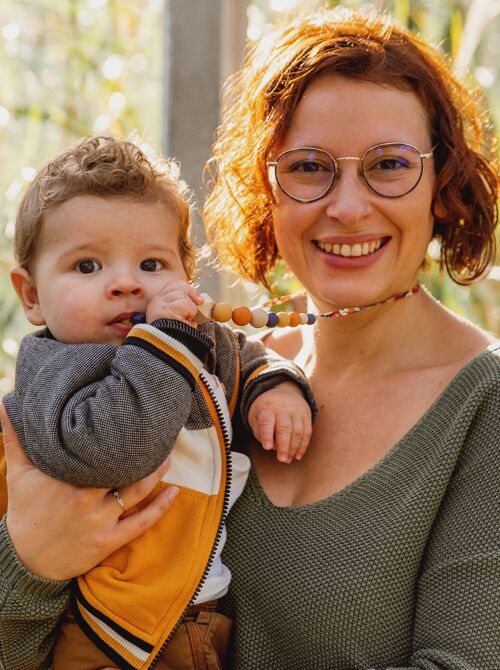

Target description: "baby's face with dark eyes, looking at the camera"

left=24, top=195, right=187, bottom=345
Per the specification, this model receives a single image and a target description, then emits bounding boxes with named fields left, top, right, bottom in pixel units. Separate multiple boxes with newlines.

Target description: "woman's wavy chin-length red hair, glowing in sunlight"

left=204, top=10, right=498, bottom=286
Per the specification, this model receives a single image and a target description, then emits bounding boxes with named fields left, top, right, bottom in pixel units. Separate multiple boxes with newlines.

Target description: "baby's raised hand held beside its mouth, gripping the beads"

left=146, top=280, right=203, bottom=328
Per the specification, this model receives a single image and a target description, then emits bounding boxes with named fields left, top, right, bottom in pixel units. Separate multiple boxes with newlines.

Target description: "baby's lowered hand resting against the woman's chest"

left=248, top=382, right=312, bottom=463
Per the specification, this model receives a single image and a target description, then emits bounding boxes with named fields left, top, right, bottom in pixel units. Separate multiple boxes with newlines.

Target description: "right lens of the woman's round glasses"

left=362, top=144, right=423, bottom=198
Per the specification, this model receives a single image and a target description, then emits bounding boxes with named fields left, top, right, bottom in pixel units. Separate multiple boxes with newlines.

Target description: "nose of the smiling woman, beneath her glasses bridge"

left=326, top=166, right=372, bottom=225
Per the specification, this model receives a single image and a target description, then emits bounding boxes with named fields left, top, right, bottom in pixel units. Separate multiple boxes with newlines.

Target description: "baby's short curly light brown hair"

left=14, top=136, right=197, bottom=280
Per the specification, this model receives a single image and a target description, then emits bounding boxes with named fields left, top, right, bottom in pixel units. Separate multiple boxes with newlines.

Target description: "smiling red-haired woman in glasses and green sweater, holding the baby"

left=0, top=6, right=500, bottom=670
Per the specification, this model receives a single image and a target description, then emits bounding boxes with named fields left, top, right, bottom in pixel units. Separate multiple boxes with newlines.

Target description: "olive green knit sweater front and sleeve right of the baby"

left=224, top=344, right=500, bottom=670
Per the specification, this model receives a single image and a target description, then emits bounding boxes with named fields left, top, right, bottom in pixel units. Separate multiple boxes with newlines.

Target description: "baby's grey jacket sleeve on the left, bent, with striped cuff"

left=5, top=320, right=212, bottom=488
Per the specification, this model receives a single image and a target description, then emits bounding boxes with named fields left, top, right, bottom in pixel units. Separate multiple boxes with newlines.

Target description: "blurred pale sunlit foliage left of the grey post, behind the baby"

left=0, top=0, right=163, bottom=396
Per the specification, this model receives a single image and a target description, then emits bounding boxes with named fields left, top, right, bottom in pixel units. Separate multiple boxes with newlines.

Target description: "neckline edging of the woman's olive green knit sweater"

left=248, top=340, right=500, bottom=514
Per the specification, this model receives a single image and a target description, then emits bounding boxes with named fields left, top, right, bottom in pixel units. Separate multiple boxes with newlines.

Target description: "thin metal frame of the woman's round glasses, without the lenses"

left=266, top=142, right=437, bottom=203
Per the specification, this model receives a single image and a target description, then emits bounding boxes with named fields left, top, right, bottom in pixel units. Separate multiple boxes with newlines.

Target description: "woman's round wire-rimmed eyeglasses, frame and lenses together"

left=267, top=142, right=436, bottom=202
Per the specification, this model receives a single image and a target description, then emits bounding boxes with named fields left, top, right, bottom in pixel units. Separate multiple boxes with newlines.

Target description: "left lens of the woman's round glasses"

left=276, top=149, right=335, bottom=202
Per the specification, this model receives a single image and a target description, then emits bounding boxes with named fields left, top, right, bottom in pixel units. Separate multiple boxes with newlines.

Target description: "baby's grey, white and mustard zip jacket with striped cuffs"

left=0, top=319, right=314, bottom=670
